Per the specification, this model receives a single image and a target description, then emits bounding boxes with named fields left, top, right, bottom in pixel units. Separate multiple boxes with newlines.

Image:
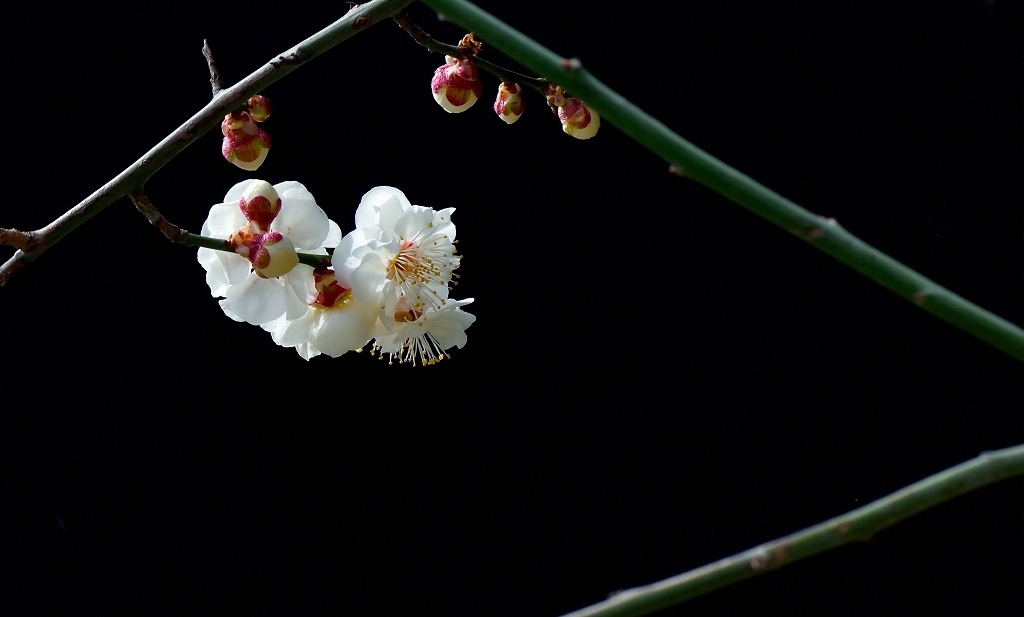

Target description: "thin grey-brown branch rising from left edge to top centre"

left=0, top=0, right=412, bottom=285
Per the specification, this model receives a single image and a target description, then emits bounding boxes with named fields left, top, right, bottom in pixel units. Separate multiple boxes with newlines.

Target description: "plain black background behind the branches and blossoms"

left=0, top=0, right=1024, bottom=616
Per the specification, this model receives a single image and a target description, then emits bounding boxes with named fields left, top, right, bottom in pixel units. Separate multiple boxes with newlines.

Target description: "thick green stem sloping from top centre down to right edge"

left=422, top=0, right=1024, bottom=360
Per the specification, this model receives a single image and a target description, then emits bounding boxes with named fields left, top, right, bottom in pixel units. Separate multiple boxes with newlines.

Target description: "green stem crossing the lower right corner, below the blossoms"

left=564, top=445, right=1024, bottom=617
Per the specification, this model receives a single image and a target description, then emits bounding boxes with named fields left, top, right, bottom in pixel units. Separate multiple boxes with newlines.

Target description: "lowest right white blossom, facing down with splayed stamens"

left=374, top=298, right=476, bottom=366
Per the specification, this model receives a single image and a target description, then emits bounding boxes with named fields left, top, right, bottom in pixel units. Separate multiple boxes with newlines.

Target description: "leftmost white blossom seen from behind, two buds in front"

left=198, top=180, right=341, bottom=324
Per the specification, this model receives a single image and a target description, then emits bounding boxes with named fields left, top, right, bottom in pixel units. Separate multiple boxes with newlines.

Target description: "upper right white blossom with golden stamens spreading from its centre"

left=333, top=186, right=461, bottom=329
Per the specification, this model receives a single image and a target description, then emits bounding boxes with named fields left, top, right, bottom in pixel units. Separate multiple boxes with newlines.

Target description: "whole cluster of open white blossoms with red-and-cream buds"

left=199, top=180, right=476, bottom=365
